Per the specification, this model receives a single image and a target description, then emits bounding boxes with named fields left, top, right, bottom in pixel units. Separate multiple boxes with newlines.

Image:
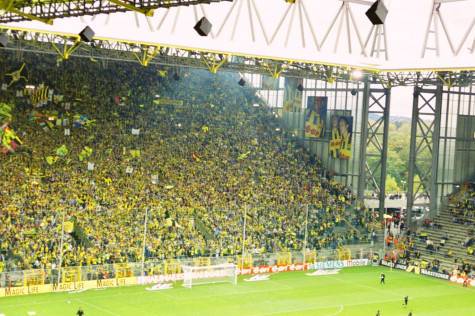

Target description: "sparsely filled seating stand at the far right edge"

left=386, top=183, right=475, bottom=278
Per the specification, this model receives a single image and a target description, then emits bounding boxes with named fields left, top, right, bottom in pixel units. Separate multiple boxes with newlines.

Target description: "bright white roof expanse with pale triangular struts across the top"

left=3, top=0, right=475, bottom=72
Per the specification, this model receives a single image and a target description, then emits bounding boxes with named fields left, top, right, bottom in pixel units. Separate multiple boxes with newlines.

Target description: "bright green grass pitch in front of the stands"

left=0, top=267, right=475, bottom=316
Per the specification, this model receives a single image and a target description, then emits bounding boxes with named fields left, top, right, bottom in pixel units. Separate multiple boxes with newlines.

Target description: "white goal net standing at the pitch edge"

left=182, top=263, right=237, bottom=288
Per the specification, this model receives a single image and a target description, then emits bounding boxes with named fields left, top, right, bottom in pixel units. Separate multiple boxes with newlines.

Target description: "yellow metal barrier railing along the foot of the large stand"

left=0, top=244, right=382, bottom=288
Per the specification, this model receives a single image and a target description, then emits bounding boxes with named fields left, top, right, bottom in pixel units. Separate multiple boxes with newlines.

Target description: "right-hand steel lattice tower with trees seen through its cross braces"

left=407, top=81, right=443, bottom=222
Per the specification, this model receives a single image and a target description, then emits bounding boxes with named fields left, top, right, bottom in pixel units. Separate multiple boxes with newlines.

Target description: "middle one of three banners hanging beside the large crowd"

left=305, top=96, right=328, bottom=138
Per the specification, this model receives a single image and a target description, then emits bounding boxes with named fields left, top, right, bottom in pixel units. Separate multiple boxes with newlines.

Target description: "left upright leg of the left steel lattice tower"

left=358, top=76, right=371, bottom=201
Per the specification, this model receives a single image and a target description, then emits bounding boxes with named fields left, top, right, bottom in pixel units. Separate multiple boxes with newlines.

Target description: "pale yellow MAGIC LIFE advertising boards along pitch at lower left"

left=0, top=277, right=138, bottom=297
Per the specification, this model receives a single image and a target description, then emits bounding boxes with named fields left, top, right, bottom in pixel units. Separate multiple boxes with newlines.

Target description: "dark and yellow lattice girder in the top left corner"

left=0, top=0, right=233, bottom=23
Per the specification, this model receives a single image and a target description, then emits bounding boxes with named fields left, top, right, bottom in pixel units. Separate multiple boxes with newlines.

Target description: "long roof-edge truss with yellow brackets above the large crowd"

left=0, top=29, right=364, bottom=79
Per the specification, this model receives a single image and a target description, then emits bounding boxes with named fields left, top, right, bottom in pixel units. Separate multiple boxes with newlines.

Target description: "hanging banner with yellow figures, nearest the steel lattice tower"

left=329, top=115, right=353, bottom=160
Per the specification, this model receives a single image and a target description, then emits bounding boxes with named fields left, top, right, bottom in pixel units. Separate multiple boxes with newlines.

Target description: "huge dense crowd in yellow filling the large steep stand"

left=0, top=53, right=377, bottom=270
